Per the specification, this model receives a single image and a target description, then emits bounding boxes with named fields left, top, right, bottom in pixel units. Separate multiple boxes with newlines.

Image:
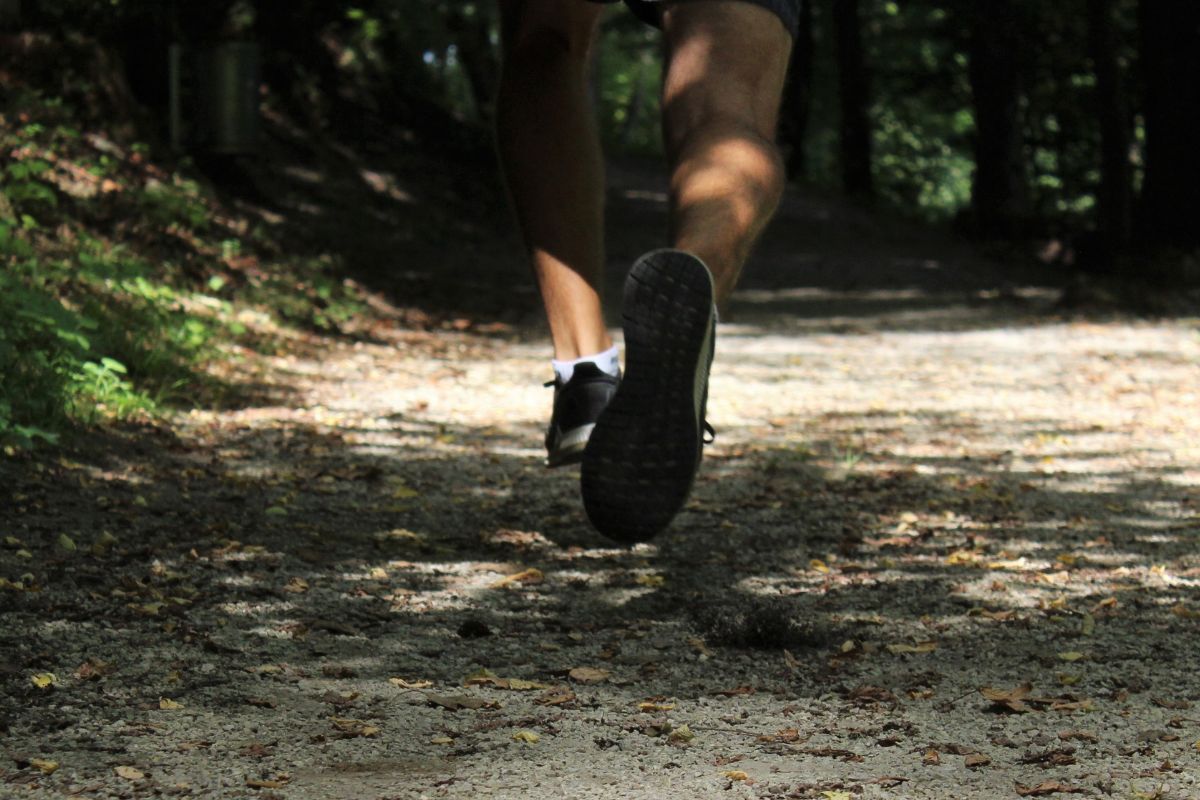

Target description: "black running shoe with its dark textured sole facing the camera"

left=581, top=249, right=716, bottom=542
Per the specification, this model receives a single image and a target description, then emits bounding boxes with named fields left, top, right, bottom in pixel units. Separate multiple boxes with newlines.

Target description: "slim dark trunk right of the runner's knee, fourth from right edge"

left=833, top=0, right=875, bottom=198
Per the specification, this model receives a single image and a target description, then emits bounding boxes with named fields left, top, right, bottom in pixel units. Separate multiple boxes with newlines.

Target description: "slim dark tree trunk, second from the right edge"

left=1087, top=0, right=1133, bottom=266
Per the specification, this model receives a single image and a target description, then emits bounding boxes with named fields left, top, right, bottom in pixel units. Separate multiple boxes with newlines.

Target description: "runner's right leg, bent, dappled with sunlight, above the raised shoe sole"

left=662, top=0, right=792, bottom=306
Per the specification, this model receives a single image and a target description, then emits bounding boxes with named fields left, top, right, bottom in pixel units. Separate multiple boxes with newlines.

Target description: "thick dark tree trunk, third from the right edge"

left=968, top=0, right=1030, bottom=239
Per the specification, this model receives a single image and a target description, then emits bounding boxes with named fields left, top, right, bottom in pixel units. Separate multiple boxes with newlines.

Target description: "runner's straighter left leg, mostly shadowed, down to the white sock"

left=496, top=0, right=612, bottom=361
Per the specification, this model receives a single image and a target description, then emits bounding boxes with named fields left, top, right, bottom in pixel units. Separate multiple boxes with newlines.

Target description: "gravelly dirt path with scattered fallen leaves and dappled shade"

left=7, top=175, right=1200, bottom=800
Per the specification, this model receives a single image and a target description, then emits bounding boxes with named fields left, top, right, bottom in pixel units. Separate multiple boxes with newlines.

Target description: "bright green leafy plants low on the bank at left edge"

left=0, top=223, right=212, bottom=445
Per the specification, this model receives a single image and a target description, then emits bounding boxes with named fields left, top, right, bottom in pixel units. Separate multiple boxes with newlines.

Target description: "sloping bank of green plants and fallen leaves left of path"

left=0, top=65, right=382, bottom=452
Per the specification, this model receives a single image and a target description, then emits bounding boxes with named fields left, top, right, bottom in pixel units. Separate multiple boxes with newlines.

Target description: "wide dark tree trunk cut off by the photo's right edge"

left=1140, top=0, right=1200, bottom=246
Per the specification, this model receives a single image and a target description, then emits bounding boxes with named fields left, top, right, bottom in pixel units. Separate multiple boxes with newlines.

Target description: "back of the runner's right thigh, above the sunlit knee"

left=662, top=0, right=792, bottom=149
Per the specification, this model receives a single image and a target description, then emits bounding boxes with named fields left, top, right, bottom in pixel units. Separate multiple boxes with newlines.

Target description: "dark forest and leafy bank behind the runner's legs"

left=0, top=0, right=1200, bottom=441
